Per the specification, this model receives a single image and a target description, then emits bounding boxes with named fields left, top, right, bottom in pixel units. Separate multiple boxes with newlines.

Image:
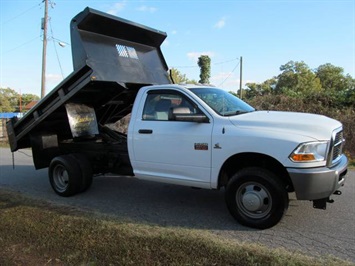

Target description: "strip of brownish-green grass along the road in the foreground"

left=0, top=190, right=353, bottom=266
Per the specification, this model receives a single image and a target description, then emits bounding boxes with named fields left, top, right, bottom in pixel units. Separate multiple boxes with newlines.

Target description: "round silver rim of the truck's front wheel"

left=236, top=182, right=272, bottom=219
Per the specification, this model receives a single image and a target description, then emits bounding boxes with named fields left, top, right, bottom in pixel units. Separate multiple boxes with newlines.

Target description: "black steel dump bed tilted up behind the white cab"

left=7, top=8, right=170, bottom=155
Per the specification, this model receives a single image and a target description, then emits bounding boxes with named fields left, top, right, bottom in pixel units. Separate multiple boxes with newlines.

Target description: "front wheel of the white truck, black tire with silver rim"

left=225, top=167, right=289, bottom=229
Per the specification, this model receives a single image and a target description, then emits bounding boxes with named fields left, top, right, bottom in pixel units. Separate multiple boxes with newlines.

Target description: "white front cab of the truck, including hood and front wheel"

left=128, top=85, right=347, bottom=228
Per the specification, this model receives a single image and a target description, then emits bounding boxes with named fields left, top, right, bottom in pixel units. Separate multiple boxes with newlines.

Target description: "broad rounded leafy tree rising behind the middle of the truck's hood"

left=275, top=61, right=322, bottom=97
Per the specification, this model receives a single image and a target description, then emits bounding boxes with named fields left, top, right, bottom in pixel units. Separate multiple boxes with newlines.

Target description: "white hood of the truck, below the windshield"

left=230, top=111, right=342, bottom=140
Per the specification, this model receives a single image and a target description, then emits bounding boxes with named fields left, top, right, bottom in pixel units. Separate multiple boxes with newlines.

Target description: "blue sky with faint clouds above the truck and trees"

left=0, top=0, right=355, bottom=95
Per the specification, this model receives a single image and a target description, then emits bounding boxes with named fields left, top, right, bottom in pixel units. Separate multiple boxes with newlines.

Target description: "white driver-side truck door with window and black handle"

left=130, top=90, right=213, bottom=188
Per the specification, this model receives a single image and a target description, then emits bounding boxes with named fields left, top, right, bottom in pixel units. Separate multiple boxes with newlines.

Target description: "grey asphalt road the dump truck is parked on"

left=0, top=148, right=355, bottom=263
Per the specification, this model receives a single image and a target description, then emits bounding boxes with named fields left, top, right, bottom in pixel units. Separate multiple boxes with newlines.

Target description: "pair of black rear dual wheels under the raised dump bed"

left=48, top=154, right=93, bottom=197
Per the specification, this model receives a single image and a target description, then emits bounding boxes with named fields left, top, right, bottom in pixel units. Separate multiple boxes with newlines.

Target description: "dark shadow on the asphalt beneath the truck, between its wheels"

left=75, top=176, right=262, bottom=231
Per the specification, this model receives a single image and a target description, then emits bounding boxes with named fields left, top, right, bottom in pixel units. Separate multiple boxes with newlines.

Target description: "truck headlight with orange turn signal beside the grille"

left=290, top=141, right=328, bottom=163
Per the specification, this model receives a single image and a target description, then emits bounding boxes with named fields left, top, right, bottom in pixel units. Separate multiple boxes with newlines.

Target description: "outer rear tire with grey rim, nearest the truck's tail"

left=48, top=155, right=82, bottom=197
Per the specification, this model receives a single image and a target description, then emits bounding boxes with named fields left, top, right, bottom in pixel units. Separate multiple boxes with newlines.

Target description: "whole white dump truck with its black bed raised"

left=7, top=8, right=348, bottom=229
